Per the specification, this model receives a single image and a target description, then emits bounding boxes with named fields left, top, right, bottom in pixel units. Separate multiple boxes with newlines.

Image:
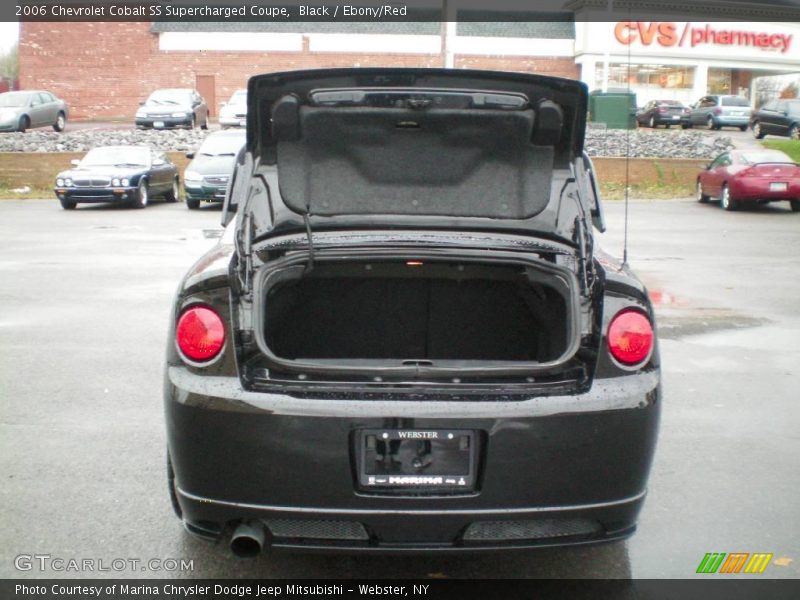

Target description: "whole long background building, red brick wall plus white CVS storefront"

left=19, top=13, right=800, bottom=119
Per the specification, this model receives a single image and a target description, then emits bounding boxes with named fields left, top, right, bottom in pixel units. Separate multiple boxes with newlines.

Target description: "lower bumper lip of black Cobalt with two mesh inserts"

left=178, top=489, right=644, bottom=553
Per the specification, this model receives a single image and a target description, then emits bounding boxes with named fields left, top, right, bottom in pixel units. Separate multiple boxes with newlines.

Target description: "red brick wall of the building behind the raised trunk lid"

left=19, top=22, right=579, bottom=119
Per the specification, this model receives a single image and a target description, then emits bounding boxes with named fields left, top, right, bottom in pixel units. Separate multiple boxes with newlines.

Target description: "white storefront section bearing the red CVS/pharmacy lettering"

left=575, top=21, right=800, bottom=106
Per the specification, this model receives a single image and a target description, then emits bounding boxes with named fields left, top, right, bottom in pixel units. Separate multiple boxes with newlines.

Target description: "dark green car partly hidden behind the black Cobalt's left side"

left=183, top=129, right=245, bottom=209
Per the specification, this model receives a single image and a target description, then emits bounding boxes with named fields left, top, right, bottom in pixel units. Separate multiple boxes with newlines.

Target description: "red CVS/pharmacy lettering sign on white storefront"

left=614, top=21, right=792, bottom=53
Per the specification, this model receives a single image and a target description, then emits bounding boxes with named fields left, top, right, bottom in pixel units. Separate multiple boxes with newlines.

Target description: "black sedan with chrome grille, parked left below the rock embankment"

left=54, top=146, right=179, bottom=209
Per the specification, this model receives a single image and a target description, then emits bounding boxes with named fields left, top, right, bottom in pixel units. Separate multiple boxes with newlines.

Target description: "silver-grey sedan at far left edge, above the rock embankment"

left=0, top=90, right=69, bottom=132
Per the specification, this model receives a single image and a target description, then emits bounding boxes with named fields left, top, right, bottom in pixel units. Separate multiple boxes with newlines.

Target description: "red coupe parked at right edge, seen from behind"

left=697, top=150, right=800, bottom=212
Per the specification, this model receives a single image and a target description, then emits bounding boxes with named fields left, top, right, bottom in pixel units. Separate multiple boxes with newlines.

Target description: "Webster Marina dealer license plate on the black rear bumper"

left=355, top=429, right=477, bottom=493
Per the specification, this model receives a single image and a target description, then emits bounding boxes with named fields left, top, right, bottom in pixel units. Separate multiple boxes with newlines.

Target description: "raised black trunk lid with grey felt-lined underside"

left=247, top=69, right=587, bottom=229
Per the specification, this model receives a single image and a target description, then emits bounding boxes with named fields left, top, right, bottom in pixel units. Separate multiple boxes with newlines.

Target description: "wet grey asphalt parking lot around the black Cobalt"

left=0, top=199, right=800, bottom=578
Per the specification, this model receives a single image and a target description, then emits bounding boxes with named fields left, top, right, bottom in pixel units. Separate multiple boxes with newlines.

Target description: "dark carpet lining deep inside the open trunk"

left=266, top=277, right=566, bottom=361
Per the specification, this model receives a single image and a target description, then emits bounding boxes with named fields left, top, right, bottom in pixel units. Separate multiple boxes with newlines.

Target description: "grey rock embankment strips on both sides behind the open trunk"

left=0, top=129, right=733, bottom=159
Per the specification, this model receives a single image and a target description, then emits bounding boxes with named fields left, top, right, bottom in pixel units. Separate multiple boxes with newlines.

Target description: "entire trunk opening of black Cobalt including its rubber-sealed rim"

left=257, top=251, right=578, bottom=376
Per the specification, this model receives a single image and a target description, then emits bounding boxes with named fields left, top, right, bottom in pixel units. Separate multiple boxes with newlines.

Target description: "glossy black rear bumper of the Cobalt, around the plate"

left=165, top=366, right=661, bottom=552
